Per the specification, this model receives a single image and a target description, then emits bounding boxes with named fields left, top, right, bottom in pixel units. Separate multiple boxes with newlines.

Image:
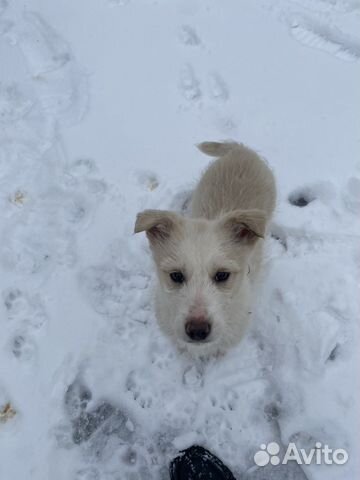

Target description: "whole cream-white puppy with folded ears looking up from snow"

left=135, top=142, right=276, bottom=355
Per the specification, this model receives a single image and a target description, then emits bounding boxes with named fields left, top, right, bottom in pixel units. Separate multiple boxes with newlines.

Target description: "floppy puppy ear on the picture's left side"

left=134, top=210, right=182, bottom=243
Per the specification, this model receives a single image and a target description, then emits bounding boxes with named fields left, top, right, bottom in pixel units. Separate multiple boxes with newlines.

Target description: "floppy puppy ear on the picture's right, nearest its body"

left=219, top=209, right=266, bottom=245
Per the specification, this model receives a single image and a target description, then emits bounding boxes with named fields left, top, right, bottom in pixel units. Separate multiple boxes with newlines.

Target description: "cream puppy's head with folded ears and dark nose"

left=135, top=210, right=266, bottom=354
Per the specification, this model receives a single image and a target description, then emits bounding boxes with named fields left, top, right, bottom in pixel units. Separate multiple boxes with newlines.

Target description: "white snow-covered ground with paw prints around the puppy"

left=0, top=0, right=360, bottom=480
